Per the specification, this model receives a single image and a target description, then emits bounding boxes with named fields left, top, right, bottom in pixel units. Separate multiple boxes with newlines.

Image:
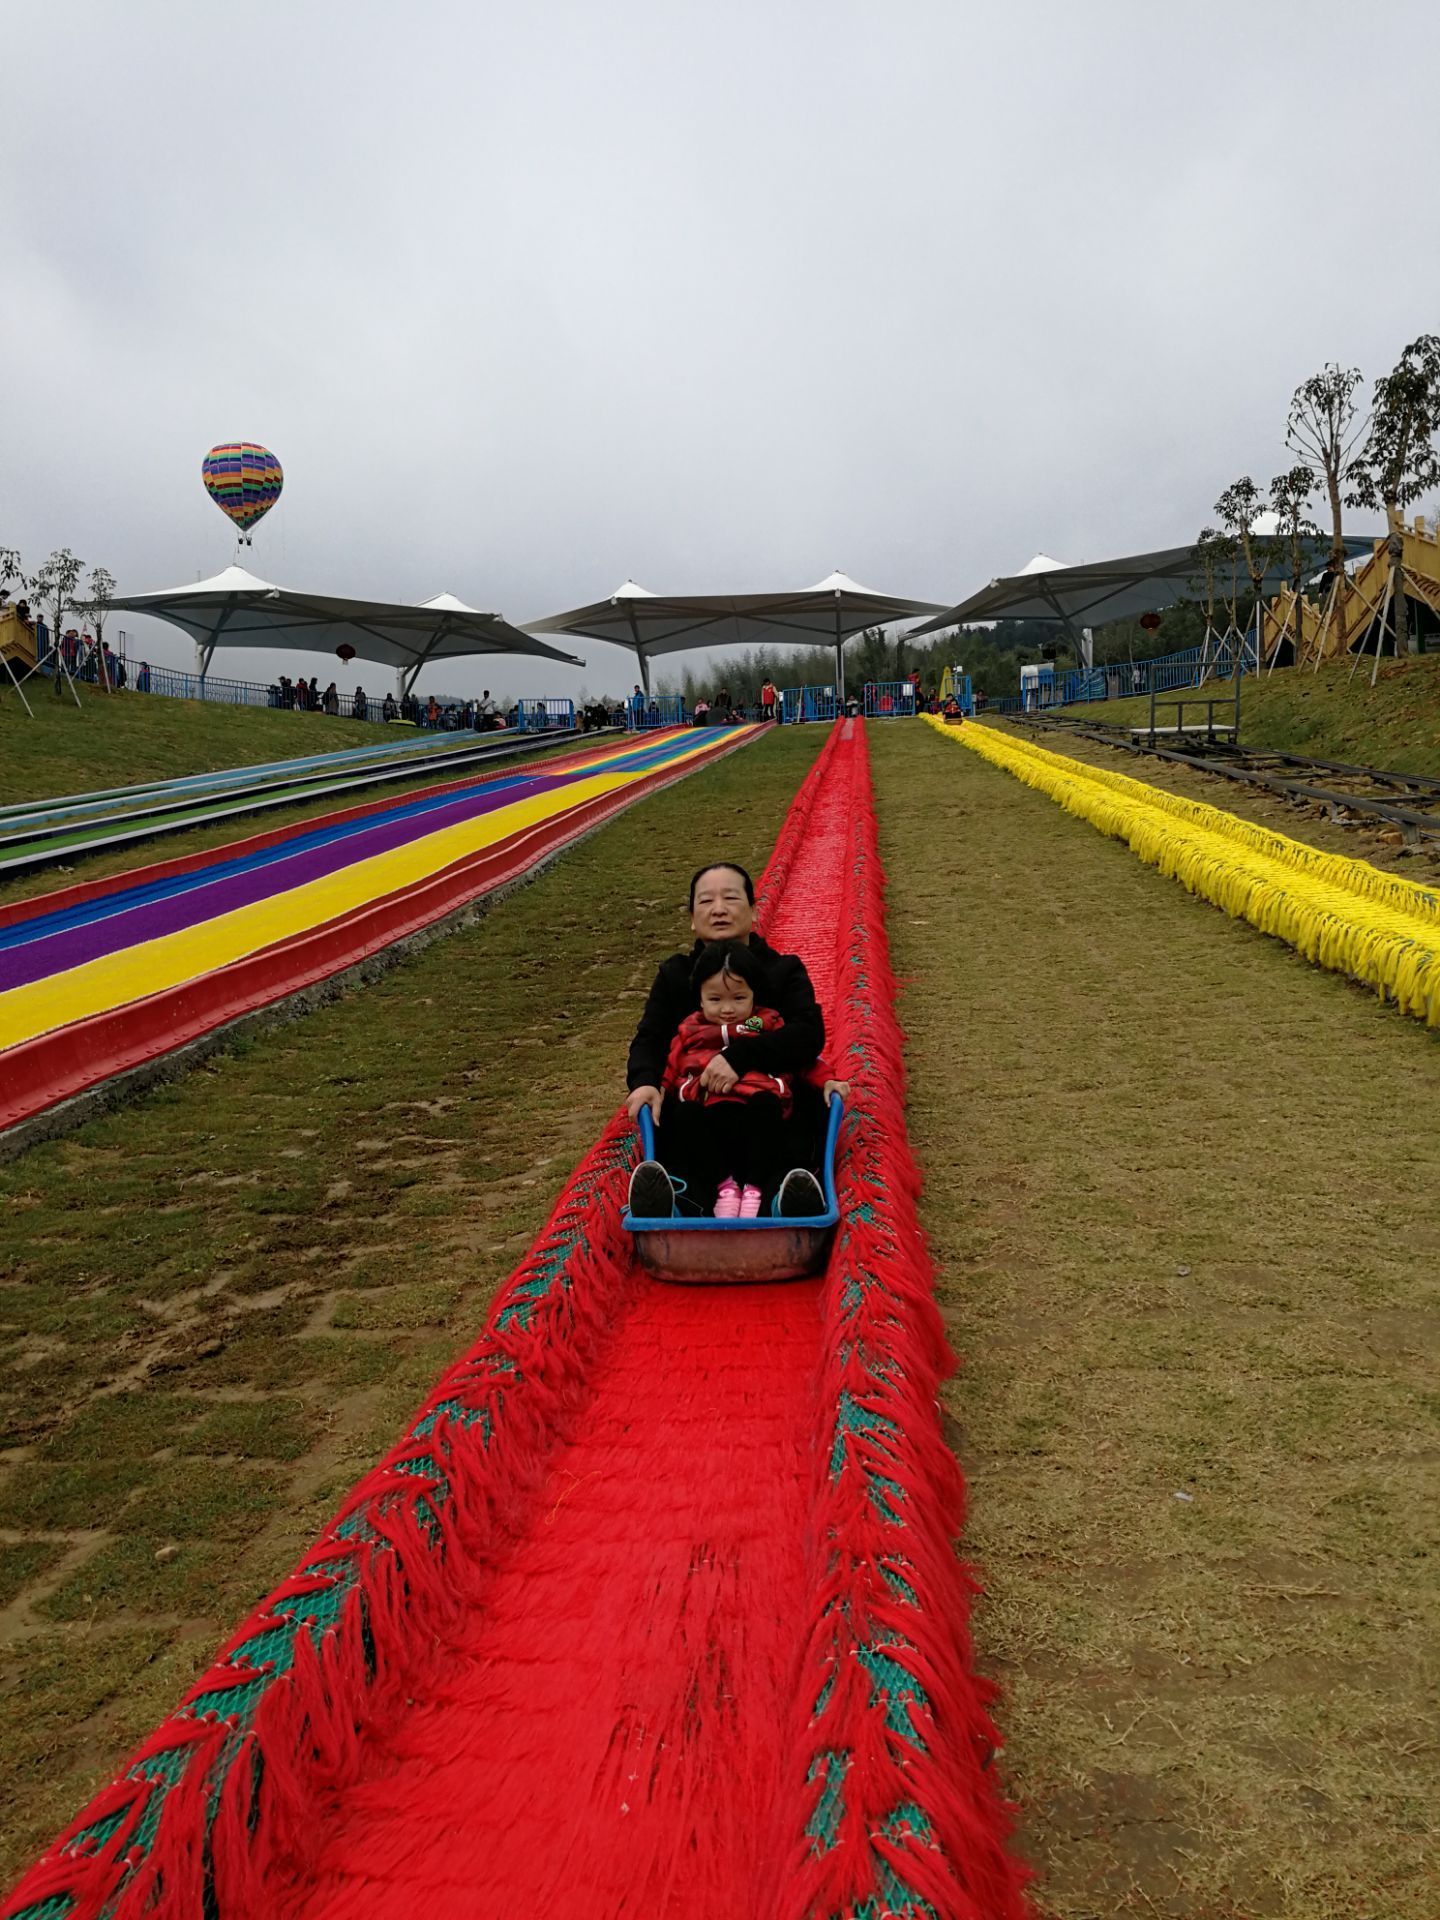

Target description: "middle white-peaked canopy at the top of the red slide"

left=530, top=574, right=939, bottom=693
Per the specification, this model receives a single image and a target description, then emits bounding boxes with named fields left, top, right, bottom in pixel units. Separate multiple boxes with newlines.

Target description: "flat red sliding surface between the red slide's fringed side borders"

left=273, top=725, right=851, bottom=1920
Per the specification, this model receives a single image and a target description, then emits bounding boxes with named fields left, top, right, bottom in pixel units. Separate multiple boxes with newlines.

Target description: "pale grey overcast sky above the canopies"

left=0, top=0, right=1440, bottom=693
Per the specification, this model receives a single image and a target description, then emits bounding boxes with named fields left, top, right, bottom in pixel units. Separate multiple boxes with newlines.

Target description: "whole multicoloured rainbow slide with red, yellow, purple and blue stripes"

left=0, top=728, right=760, bottom=1133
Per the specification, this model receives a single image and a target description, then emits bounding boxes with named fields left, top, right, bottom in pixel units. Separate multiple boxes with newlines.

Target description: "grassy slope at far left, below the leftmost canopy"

left=0, top=680, right=396, bottom=804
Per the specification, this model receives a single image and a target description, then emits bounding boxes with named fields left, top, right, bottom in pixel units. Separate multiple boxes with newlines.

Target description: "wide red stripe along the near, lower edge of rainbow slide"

left=0, top=733, right=758, bottom=1133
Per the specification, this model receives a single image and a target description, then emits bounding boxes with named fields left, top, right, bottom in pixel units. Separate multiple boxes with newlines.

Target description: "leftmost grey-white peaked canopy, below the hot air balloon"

left=113, top=566, right=586, bottom=693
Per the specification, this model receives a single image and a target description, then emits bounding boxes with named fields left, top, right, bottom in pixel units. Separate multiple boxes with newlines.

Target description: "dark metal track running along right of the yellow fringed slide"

left=1004, top=714, right=1440, bottom=847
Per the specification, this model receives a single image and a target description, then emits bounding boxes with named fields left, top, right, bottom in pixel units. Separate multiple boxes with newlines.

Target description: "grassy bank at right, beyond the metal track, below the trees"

left=1064, top=655, right=1440, bottom=776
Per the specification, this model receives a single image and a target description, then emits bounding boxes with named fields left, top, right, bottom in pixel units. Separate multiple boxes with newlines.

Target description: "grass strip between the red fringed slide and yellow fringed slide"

left=872, top=726, right=1440, bottom=1920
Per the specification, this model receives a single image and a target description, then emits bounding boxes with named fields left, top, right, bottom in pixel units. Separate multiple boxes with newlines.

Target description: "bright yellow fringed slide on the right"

left=925, top=716, right=1440, bottom=1027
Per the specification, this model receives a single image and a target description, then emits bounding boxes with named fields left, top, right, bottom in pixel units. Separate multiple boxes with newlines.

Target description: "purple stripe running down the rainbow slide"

left=0, top=770, right=564, bottom=993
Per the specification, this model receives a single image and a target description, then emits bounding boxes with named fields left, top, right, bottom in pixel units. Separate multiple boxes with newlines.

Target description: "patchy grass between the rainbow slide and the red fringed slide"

left=0, top=721, right=822, bottom=1882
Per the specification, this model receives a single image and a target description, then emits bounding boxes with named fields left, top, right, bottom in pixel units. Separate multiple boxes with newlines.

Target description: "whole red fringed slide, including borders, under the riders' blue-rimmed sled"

left=4, top=722, right=1023, bottom=1920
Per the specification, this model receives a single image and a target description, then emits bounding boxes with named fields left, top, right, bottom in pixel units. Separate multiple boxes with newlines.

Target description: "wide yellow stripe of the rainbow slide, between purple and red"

left=0, top=728, right=755, bottom=1052
